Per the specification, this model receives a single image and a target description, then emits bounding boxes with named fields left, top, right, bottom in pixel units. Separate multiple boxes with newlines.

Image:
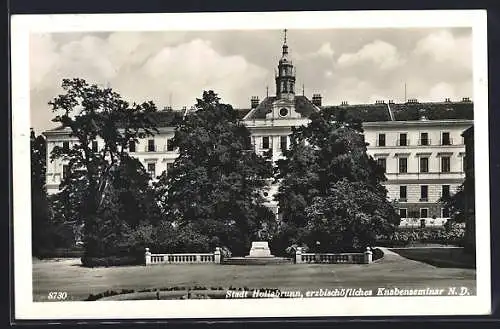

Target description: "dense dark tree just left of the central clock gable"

left=157, top=91, right=275, bottom=254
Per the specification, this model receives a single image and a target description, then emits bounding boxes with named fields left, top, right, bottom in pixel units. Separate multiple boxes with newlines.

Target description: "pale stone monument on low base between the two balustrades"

left=223, top=241, right=293, bottom=265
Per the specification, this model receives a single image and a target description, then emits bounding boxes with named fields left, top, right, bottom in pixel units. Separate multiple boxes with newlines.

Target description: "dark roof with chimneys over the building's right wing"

left=323, top=101, right=474, bottom=122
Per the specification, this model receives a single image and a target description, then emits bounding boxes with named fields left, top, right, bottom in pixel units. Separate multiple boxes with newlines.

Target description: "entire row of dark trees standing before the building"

left=32, top=79, right=464, bottom=259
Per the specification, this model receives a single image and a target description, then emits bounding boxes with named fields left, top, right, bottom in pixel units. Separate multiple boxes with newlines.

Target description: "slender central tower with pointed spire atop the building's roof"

left=275, top=29, right=295, bottom=100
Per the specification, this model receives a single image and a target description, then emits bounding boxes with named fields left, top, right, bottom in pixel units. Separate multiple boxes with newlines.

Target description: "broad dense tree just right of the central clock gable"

left=276, top=109, right=399, bottom=250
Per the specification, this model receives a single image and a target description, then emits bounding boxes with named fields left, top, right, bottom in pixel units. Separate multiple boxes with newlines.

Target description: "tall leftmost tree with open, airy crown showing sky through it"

left=49, top=78, right=157, bottom=256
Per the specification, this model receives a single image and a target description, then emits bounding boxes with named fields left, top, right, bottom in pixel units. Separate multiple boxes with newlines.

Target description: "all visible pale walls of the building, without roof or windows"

left=46, top=119, right=472, bottom=226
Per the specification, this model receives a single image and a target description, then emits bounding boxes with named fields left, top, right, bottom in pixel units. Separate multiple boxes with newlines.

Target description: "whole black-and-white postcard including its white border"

left=12, top=10, right=491, bottom=319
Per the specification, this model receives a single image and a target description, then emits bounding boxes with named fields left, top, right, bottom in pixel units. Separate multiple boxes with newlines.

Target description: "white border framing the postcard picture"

left=11, top=10, right=491, bottom=320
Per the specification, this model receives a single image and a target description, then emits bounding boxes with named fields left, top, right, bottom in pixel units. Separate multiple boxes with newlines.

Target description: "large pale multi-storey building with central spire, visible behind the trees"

left=44, top=32, right=473, bottom=226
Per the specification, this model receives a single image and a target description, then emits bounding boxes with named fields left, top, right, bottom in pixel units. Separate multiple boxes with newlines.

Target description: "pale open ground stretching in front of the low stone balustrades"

left=33, top=247, right=476, bottom=301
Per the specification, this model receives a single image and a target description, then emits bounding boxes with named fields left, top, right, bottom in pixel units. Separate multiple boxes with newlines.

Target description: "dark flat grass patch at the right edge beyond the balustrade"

left=391, top=248, right=476, bottom=269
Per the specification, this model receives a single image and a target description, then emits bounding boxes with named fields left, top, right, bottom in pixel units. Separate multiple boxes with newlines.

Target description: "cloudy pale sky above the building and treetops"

left=29, top=28, right=473, bottom=133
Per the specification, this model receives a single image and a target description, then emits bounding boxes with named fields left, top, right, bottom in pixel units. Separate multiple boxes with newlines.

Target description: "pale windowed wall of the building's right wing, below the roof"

left=364, top=120, right=472, bottom=227
